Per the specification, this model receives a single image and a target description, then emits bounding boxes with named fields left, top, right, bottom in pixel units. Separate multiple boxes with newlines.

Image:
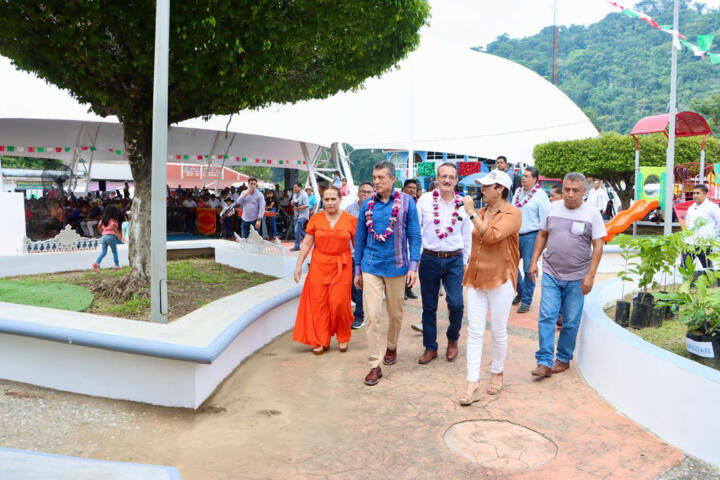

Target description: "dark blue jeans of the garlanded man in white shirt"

left=418, top=253, right=464, bottom=351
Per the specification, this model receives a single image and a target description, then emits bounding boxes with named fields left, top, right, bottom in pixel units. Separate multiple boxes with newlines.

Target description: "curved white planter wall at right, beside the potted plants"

left=576, top=280, right=720, bottom=466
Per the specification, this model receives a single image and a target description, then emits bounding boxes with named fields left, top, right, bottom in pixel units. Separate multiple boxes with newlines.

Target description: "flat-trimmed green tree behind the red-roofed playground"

left=533, top=132, right=720, bottom=208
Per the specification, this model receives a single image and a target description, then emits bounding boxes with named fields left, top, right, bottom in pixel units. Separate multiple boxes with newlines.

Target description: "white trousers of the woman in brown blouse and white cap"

left=467, top=280, right=515, bottom=382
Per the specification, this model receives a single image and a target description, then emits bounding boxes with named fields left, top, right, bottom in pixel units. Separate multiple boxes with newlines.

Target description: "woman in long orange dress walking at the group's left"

left=293, top=187, right=357, bottom=355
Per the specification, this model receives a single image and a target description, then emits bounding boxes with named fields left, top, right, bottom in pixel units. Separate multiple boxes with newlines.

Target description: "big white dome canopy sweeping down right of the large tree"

left=180, top=37, right=598, bottom=163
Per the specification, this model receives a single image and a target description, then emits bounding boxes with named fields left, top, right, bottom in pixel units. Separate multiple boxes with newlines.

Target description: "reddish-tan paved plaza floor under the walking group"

left=0, top=272, right=716, bottom=480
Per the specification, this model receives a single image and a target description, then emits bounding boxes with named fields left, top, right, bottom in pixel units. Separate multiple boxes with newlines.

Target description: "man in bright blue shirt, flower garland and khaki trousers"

left=354, top=161, right=422, bottom=385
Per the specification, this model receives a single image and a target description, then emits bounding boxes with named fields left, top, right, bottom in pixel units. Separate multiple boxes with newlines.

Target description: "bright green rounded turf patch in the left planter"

left=0, top=280, right=93, bottom=312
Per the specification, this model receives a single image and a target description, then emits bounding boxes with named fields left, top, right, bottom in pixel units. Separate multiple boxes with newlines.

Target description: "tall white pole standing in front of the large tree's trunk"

left=150, top=0, right=170, bottom=323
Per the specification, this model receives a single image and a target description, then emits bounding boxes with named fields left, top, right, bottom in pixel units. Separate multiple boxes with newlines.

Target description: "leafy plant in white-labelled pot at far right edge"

left=659, top=261, right=720, bottom=360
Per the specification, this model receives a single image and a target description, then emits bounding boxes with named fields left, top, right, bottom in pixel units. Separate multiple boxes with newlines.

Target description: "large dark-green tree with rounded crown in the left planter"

left=0, top=0, right=429, bottom=292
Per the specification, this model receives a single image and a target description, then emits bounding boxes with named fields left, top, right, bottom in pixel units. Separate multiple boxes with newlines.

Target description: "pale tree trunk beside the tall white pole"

left=93, top=122, right=152, bottom=300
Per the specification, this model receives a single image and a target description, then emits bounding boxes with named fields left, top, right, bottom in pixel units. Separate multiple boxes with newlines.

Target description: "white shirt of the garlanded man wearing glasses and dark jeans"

left=417, top=192, right=472, bottom=264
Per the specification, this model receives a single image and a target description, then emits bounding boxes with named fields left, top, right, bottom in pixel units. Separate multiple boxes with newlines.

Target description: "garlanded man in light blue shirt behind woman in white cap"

left=513, top=167, right=550, bottom=313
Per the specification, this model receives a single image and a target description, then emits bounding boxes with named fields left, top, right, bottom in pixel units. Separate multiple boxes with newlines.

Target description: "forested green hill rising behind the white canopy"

left=486, top=0, right=720, bottom=133
